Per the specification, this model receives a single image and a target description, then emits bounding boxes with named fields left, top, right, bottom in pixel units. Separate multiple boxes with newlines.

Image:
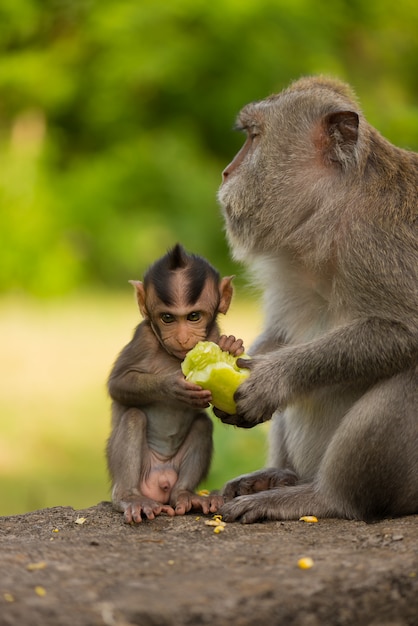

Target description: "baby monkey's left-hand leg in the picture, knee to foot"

left=107, top=408, right=174, bottom=523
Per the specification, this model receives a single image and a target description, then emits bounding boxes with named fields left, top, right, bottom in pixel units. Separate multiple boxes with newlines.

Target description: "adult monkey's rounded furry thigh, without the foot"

left=318, top=368, right=418, bottom=520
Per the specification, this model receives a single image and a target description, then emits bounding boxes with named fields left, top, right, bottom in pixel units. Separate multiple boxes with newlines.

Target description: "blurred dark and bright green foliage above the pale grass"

left=0, top=0, right=418, bottom=295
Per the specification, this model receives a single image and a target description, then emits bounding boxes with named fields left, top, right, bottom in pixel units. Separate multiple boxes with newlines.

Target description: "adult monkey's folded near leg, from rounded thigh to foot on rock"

left=221, top=370, right=418, bottom=523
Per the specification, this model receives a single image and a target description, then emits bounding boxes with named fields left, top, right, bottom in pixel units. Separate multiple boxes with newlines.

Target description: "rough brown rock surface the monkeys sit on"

left=0, top=502, right=418, bottom=626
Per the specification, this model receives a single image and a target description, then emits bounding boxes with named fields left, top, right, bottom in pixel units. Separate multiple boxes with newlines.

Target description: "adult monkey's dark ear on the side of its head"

left=321, top=111, right=359, bottom=165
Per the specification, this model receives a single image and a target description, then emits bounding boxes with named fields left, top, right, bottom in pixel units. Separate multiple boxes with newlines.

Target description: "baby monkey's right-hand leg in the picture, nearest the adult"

left=170, top=413, right=223, bottom=515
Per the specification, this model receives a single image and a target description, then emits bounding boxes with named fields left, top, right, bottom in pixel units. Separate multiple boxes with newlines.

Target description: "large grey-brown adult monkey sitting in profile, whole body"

left=219, top=77, right=418, bottom=523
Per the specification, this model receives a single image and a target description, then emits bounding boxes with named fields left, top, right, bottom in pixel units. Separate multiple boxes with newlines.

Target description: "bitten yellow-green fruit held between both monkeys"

left=181, top=341, right=250, bottom=415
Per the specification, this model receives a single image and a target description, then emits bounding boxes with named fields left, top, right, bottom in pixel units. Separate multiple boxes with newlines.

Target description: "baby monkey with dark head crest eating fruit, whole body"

left=107, top=244, right=244, bottom=523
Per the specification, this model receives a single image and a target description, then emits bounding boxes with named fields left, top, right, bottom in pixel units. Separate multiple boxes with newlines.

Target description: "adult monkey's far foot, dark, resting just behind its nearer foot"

left=221, top=467, right=298, bottom=500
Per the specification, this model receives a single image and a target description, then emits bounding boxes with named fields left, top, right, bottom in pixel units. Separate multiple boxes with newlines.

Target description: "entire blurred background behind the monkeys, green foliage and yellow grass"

left=0, top=0, right=418, bottom=515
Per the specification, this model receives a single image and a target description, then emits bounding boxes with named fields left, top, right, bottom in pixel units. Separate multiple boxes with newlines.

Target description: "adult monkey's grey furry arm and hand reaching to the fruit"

left=233, top=317, right=418, bottom=427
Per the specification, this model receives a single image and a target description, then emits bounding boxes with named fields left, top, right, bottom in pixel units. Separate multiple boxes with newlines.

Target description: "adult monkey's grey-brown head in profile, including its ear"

left=218, top=80, right=358, bottom=260
